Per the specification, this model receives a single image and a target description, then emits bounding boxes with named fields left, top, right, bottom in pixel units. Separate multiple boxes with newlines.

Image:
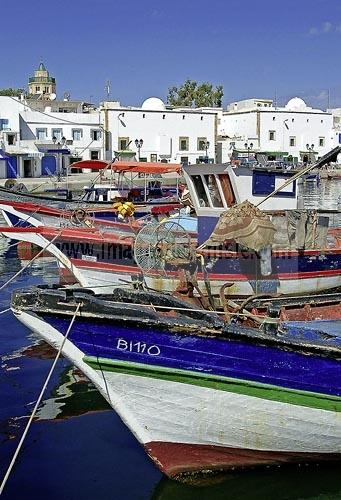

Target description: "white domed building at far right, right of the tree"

left=218, top=97, right=335, bottom=163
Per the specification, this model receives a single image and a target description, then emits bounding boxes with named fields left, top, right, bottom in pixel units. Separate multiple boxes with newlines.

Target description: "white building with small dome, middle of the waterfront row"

left=102, top=97, right=216, bottom=163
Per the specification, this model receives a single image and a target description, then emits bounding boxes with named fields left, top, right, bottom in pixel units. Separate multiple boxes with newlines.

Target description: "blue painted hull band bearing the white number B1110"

left=44, top=315, right=341, bottom=396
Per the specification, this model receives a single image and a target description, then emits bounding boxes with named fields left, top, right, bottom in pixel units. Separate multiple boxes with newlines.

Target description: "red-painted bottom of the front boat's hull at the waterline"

left=145, top=441, right=341, bottom=477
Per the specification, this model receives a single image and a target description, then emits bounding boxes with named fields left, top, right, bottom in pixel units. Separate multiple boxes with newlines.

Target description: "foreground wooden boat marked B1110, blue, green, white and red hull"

left=11, top=287, right=341, bottom=481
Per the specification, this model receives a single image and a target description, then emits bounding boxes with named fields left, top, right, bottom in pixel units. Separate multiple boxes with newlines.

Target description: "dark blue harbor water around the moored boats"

left=0, top=180, right=341, bottom=500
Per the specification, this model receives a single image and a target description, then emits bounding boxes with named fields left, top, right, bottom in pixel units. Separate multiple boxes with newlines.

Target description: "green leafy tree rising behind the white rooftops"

left=167, top=79, right=224, bottom=108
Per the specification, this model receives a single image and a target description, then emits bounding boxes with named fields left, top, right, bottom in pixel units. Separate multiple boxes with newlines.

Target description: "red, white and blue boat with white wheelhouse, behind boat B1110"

left=1, top=148, right=341, bottom=302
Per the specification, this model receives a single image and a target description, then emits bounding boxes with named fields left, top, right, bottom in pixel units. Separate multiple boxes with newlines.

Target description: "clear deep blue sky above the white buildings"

left=0, top=0, right=341, bottom=108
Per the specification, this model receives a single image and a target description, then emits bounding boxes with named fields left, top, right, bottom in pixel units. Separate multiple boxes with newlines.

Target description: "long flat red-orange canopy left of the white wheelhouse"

left=70, top=160, right=181, bottom=174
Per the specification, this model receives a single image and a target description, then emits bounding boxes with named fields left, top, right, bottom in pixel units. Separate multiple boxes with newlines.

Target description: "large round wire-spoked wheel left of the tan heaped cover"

left=134, top=220, right=194, bottom=276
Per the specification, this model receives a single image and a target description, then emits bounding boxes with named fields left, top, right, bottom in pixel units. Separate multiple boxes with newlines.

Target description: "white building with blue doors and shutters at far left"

left=0, top=96, right=104, bottom=178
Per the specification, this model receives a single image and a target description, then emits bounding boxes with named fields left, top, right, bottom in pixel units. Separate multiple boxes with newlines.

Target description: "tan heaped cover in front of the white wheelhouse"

left=204, top=201, right=276, bottom=251
